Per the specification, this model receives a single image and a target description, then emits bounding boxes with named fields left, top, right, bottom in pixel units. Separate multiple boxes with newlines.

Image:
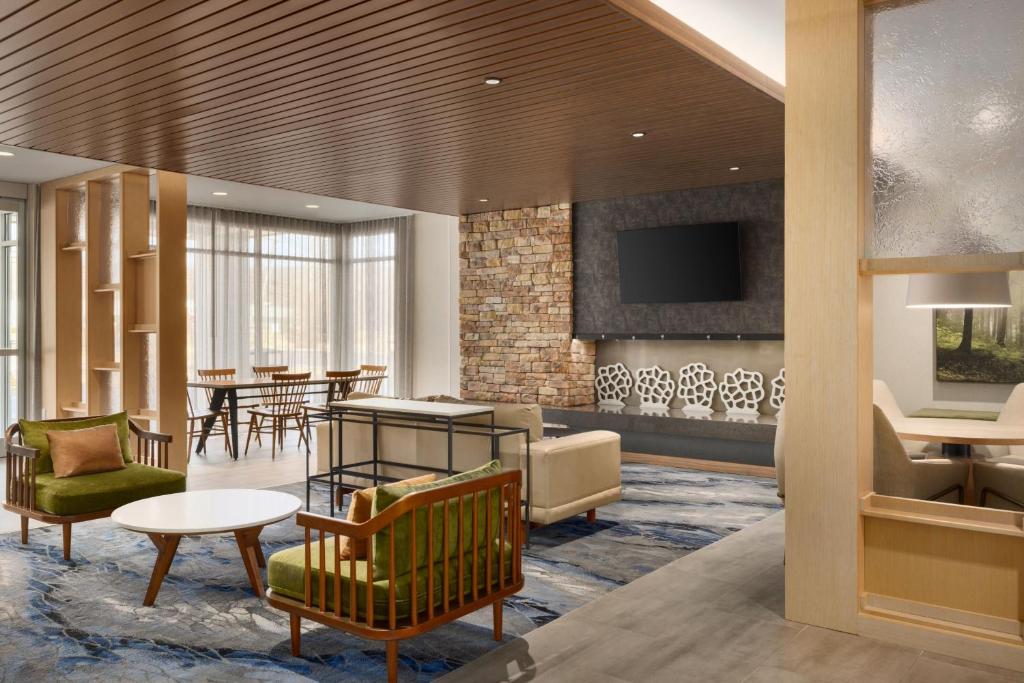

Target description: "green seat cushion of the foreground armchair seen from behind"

left=266, top=537, right=512, bottom=620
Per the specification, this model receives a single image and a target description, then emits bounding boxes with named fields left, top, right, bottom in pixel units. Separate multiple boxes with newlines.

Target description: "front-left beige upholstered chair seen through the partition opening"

left=873, top=405, right=970, bottom=503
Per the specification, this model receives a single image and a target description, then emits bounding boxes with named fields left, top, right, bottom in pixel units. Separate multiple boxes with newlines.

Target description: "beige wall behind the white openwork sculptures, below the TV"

left=597, top=340, right=783, bottom=415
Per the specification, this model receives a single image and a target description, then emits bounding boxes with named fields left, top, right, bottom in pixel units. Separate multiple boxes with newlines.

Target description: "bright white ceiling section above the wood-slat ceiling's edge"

left=653, top=0, right=785, bottom=85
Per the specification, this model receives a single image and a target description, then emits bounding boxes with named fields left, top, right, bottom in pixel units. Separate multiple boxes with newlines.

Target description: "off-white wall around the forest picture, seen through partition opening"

left=874, top=275, right=1013, bottom=414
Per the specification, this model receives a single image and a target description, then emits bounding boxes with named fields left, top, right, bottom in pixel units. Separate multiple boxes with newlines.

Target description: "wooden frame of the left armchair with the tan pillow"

left=3, top=418, right=171, bottom=560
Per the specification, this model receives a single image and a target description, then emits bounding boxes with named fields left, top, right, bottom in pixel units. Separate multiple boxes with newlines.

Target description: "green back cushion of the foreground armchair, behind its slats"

left=373, top=460, right=502, bottom=578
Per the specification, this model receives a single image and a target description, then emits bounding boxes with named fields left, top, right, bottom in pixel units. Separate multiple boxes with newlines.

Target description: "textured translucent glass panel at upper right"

left=866, top=0, right=1024, bottom=257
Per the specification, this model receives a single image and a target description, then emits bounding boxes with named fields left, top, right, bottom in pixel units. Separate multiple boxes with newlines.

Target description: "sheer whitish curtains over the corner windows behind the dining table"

left=188, top=207, right=412, bottom=395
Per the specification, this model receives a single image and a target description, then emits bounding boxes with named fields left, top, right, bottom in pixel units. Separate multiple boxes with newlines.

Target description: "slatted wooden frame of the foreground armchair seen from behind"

left=266, top=470, right=523, bottom=683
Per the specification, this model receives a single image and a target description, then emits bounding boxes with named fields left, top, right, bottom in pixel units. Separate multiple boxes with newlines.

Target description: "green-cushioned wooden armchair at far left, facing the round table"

left=3, top=413, right=185, bottom=560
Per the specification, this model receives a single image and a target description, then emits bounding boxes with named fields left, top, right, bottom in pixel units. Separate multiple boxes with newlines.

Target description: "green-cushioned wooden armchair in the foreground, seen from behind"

left=266, top=462, right=523, bottom=683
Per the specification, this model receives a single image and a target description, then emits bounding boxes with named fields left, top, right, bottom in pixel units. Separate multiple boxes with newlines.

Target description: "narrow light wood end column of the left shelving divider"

left=155, top=171, right=188, bottom=472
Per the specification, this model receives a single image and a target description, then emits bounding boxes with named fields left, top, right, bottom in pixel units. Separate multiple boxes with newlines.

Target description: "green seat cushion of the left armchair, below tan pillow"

left=36, top=463, right=185, bottom=515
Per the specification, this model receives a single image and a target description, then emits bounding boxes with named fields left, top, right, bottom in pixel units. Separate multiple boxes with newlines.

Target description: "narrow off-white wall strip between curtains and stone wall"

left=413, top=213, right=459, bottom=396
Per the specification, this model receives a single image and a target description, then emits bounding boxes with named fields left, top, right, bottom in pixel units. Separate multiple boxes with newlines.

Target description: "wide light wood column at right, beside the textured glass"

left=785, top=0, right=871, bottom=633
